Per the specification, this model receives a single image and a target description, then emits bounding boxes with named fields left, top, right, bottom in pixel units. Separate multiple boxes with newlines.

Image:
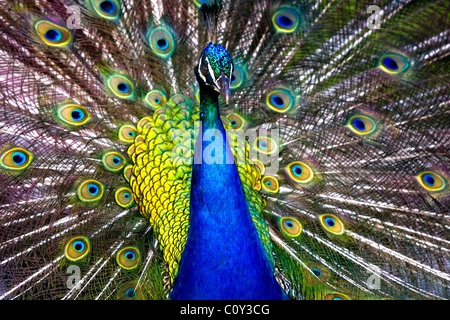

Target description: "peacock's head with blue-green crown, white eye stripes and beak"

left=195, top=42, right=233, bottom=104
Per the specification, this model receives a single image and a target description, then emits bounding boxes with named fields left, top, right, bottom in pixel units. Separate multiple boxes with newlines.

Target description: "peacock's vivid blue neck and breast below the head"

left=170, top=86, right=286, bottom=300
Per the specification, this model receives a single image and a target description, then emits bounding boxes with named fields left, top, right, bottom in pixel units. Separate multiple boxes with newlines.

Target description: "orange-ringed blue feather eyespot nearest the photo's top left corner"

left=34, top=20, right=72, bottom=47
